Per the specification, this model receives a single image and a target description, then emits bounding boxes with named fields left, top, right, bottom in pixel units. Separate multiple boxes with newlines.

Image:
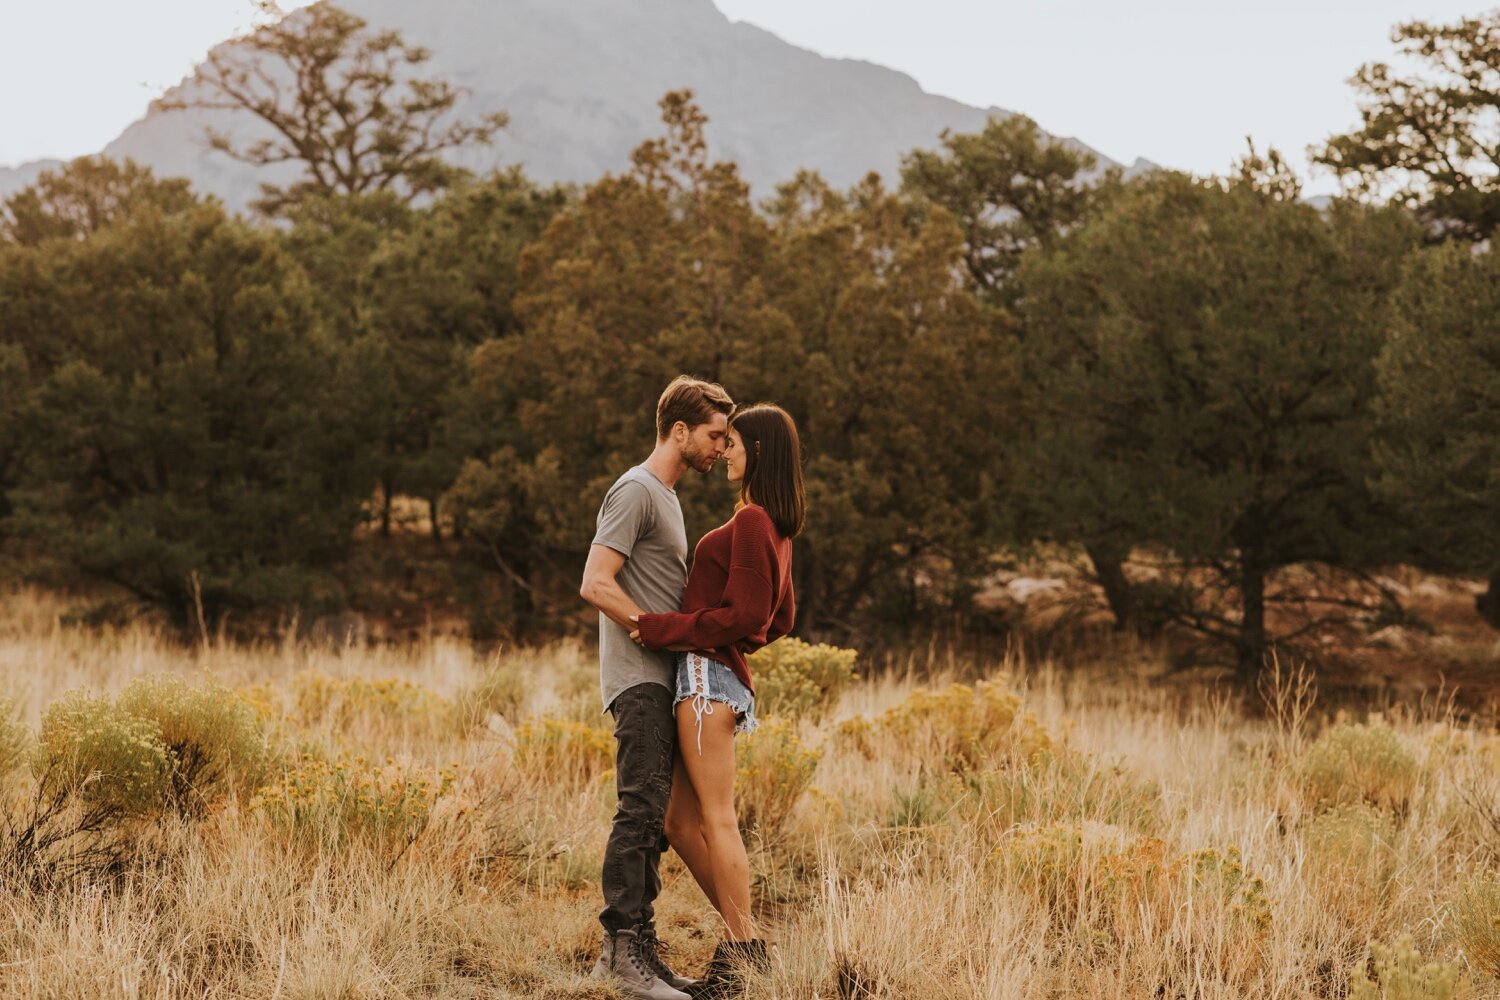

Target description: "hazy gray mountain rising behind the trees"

left=0, top=0, right=1149, bottom=208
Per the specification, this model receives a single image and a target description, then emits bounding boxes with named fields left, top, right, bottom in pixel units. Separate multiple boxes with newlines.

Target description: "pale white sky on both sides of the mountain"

left=0, top=0, right=1493, bottom=193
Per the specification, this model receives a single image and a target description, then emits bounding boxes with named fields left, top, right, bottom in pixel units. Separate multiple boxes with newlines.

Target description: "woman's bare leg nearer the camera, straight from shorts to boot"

left=677, top=700, right=755, bottom=942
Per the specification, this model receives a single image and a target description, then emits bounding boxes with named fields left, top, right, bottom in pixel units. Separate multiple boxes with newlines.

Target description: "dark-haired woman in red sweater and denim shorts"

left=633, top=403, right=806, bottom=997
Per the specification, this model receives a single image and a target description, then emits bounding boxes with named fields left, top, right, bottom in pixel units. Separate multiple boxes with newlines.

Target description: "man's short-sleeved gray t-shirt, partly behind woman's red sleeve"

left=594, top=465, right=687, bottom=709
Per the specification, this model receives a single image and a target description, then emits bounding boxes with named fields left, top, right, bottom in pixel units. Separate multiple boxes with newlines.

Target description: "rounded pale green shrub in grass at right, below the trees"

left=1298, top=723, right=1418, bottom=813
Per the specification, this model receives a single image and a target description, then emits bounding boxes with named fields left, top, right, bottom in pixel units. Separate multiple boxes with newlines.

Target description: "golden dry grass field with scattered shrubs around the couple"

left=0, top=591, right=1500, bottom=1000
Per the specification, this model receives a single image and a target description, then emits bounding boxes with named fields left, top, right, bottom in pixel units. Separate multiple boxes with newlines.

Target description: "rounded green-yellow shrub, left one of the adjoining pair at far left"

left=32, top=691, right=173, bottom=814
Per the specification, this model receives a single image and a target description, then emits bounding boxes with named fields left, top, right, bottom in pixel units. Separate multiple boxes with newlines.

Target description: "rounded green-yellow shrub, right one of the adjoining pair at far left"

left=119, top=675, right=269, bottom=814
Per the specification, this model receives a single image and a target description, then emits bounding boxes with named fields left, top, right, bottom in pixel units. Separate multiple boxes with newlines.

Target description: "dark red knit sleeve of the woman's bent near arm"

left=638, top=507, right=776, bottom=649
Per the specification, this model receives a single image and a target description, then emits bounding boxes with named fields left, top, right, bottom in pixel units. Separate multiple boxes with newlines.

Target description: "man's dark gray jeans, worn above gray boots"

left=599, top=684, right=677, bottom=934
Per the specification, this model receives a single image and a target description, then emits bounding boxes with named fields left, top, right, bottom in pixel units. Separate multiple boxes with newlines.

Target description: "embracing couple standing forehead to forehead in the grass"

left=581, top=375, right=804, bottom=1000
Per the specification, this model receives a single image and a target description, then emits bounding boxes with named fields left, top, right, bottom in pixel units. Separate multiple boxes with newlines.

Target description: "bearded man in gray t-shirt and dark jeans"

left=579, top=375, right=734, bottom=1000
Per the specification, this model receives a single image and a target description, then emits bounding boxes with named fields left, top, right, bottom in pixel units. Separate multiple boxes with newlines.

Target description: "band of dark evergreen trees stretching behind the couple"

left=0, top=4, right=1500, bottom=678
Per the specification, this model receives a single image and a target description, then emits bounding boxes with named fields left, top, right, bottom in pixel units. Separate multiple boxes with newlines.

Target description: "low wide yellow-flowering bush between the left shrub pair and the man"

left=251, top=754, right=458, bottom=847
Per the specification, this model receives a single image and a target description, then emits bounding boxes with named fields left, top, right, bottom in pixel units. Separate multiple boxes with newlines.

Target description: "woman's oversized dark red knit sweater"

left=639, top=504, right=797, bottom=693
